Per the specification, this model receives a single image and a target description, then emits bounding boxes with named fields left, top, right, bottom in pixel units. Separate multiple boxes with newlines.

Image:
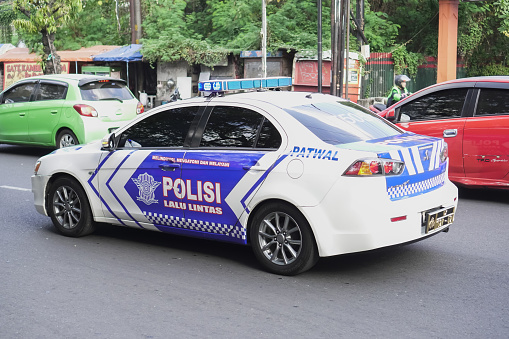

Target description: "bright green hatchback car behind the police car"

left=0, top=74, right=144, bottom=148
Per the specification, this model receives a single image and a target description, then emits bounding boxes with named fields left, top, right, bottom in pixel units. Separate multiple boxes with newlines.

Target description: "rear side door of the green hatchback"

left=28, top=80, right=67, bottom=145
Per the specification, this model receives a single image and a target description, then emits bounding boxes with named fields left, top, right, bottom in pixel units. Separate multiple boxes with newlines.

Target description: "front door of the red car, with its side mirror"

left=397, top=88, right=469, bottom=179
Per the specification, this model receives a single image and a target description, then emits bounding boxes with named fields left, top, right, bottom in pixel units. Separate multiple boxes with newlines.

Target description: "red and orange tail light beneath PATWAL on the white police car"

left=343, top=158, right=405, bottom=176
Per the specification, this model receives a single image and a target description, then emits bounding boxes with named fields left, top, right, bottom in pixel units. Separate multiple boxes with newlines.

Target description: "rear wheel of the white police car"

left=249, top=202, right=318, bottom=275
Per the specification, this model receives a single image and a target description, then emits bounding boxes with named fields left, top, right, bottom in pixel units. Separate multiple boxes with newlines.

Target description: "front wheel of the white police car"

left=48, top=178, right=95, bottom=237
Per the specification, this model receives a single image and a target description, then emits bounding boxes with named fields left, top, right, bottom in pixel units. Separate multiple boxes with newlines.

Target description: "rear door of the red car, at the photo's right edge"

left=463, top=82, right=509, bottom=181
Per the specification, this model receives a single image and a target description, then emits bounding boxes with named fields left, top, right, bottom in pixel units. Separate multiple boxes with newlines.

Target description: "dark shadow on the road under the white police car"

left=40, top=224, right=444, bottom=279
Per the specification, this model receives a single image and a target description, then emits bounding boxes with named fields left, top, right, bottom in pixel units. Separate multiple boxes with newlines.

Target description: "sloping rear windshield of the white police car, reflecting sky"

left=286, top=101, right=401, bottom=145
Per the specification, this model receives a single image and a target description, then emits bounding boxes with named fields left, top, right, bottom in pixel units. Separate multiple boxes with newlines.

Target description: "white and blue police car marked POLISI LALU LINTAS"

left=32, top=78, right=457, bottom=275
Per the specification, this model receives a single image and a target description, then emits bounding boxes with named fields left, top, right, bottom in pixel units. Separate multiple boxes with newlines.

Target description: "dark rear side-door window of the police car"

left=200, top=106, right=281, bottom=148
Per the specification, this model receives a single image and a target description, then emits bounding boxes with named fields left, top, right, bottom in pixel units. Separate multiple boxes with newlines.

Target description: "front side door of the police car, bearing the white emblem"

left=94, top=106, right=199, bottom=230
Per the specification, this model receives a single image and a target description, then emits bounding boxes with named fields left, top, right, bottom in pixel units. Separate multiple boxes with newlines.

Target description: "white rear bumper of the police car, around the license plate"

left=301, top=178, right=458, bottom=257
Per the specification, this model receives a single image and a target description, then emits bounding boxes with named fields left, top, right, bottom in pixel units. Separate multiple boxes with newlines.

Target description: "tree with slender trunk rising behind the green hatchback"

left=13, top=0, right=82, bottom=74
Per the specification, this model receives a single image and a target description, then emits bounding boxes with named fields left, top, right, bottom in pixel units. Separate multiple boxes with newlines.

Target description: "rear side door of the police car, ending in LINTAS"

left=182, top=104, right=283, bottom=243
